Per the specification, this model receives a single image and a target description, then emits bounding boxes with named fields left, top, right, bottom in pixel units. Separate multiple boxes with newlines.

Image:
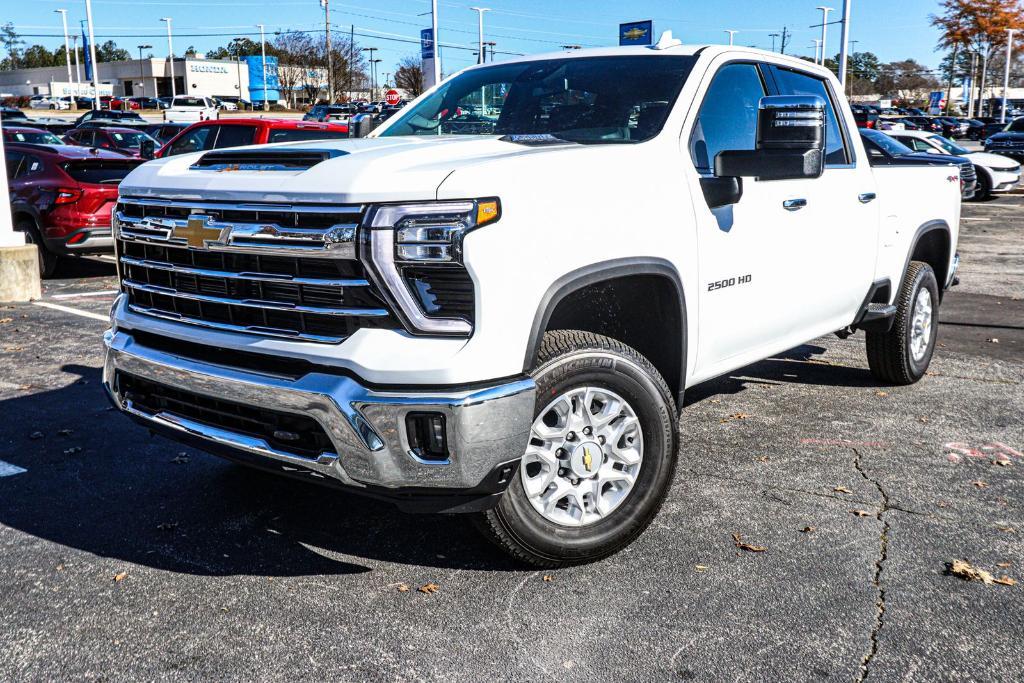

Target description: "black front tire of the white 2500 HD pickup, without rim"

left=476, top=330, right=678, bottom=567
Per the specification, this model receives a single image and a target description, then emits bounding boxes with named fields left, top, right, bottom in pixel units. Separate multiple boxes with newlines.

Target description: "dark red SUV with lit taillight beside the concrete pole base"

left=5, top=143, right=143, bottom=278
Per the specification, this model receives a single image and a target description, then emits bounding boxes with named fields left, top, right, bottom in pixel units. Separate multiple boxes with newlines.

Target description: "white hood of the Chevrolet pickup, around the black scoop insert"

left=121, top=135, right=603, bottom=204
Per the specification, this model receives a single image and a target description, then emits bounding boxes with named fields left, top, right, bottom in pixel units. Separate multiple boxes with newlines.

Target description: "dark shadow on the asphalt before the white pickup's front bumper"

left=0, top=366, right=522, bottom=577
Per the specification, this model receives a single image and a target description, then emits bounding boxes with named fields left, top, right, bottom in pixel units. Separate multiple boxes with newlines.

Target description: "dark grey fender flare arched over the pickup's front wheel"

left=523, top=256, right=689, bottom=401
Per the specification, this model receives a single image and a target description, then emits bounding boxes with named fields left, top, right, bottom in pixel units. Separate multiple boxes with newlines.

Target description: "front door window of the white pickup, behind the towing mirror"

left=690, top=63, right=765, bottom=174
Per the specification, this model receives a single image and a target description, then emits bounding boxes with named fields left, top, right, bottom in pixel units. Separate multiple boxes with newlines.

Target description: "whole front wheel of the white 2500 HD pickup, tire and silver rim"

left=478, top=330, right=677, bottom=567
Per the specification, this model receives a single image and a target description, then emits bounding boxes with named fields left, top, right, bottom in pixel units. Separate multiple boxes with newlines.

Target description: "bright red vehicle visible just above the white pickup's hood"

left=157, top=119, right=348, bottom=157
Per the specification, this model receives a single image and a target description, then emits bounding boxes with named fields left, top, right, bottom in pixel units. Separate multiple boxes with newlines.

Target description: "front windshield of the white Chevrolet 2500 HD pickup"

left=381, top=55, right=696, bottom=143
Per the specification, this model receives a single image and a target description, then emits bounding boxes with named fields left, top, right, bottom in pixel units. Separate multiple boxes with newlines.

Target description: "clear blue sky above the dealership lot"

left=9, top=0, right=941, bottom=74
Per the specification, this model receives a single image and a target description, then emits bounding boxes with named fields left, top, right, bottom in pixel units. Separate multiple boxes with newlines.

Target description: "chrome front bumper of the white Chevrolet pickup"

left=103, top=330, right=537, bottom=494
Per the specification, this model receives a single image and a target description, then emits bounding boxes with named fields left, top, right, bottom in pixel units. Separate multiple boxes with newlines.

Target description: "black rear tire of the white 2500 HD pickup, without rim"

left=867, top=261, right=939, bottom=384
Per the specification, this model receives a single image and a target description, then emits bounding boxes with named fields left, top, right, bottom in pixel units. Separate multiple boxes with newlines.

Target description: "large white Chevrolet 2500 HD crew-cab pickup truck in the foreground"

left=103, top=38, right=961, bottom=566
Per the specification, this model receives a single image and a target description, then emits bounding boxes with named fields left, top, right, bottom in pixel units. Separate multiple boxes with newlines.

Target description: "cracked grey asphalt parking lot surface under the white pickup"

left=0, top=196, right=1024, bottom=681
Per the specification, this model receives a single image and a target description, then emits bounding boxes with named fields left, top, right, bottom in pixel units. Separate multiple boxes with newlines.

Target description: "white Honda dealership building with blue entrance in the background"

left=0, top=56, right=280, bottom=102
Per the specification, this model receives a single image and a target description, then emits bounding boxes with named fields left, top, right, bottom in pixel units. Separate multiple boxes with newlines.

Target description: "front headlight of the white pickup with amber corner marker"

left=361, top=198, right=501, bottom=336
